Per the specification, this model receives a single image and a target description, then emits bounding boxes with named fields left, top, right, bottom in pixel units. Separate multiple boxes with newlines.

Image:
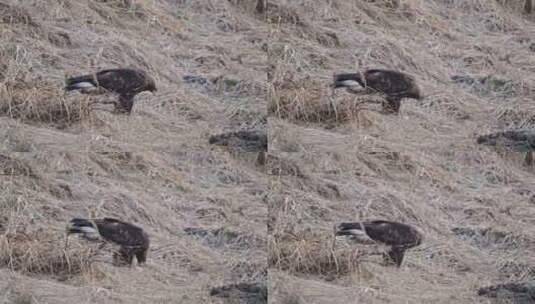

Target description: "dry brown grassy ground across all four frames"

left=0, top=0, right=535, bottom=304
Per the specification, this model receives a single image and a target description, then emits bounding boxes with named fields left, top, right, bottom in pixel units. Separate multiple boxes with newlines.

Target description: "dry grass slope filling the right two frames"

left=268, top=0, right=535, bottom=304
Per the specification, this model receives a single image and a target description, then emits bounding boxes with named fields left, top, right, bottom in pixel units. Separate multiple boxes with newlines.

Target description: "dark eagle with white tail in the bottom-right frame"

left=335, top=220, right=423, bottom=267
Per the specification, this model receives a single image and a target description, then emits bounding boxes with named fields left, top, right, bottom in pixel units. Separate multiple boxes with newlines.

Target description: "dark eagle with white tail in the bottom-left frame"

left=67, top=218, right=149, bottom=265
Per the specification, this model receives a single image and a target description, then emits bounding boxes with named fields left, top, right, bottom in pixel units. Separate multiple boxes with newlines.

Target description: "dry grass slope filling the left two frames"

left=0, top=0, right=267, bottom=303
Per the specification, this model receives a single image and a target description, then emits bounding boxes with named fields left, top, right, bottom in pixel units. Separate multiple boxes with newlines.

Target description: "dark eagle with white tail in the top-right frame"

left=332, top=69, right=423, bottom=113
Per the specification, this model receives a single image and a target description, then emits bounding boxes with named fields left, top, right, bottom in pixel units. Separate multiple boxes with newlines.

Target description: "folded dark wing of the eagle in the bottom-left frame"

left=95, top=218, right=146, bottom=246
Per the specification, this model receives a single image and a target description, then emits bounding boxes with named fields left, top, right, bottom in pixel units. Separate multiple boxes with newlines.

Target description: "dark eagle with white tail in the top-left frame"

left=65, top=69, right=156, bottom=114
